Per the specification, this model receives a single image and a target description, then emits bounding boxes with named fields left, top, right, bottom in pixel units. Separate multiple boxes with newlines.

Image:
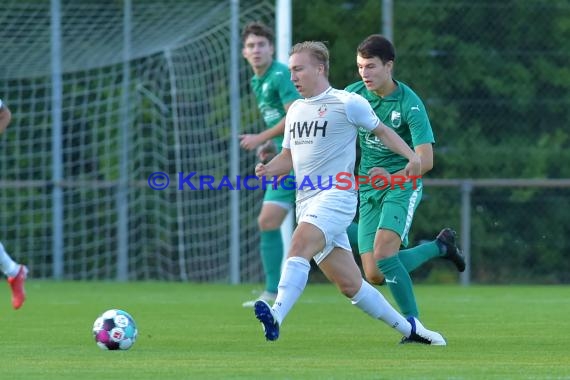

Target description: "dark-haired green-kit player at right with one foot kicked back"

left=346, top=34, right=465, bottom=317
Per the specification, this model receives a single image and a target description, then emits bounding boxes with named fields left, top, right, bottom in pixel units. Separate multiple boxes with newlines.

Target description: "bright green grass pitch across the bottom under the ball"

left=0, top=281, right=570, bottom=380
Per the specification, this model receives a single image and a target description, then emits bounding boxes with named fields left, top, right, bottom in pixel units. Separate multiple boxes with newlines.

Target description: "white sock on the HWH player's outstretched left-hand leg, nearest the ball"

left=273, top=257, right=311, bottom=324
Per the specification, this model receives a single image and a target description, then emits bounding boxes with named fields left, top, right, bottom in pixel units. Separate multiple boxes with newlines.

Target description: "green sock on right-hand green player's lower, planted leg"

left=377, top=255, right=418, bottom=318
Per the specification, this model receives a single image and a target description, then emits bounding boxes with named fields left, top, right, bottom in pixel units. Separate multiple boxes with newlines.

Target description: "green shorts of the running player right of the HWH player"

left=358, top=181, right=423, bottom=254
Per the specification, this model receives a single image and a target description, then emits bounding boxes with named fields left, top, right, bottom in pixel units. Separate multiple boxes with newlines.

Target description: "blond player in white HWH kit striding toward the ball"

left=254, top=41, right=446, bottom=345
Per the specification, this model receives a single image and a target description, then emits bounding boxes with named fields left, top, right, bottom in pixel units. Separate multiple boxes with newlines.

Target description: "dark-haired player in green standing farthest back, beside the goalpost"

left=240, top=22, right=301, bottom=307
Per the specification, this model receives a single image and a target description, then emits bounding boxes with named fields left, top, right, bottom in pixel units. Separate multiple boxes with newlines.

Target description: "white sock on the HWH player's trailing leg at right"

left=351, top=280, right=412, bottom=336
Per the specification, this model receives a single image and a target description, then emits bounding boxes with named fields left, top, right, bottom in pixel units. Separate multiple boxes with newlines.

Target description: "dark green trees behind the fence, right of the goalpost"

left=293, top=0, right=570, bottom=283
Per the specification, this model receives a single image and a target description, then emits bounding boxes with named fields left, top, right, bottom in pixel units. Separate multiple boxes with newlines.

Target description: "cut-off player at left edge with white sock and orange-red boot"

left=0, top=99, right=28, bottom=309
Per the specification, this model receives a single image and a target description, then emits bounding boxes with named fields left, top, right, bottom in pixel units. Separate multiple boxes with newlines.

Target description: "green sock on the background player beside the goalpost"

left=261, top=230, right=283, bottom=293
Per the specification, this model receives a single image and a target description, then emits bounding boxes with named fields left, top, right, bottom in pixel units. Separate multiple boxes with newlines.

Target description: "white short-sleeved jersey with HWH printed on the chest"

left=283, top=87, right=380, bottom=202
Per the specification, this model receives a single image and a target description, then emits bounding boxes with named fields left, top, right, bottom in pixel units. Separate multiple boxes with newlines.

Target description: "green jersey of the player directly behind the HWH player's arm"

left=346, top=81, right=435, bottom=191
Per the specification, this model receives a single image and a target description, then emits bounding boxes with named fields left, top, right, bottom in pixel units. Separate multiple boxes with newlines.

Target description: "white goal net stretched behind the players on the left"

left=0, top=0, right=274, bottom=282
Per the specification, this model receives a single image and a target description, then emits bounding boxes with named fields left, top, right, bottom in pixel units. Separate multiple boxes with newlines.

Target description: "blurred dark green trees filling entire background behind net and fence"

left=0, top=0, right=570, bottom=283
